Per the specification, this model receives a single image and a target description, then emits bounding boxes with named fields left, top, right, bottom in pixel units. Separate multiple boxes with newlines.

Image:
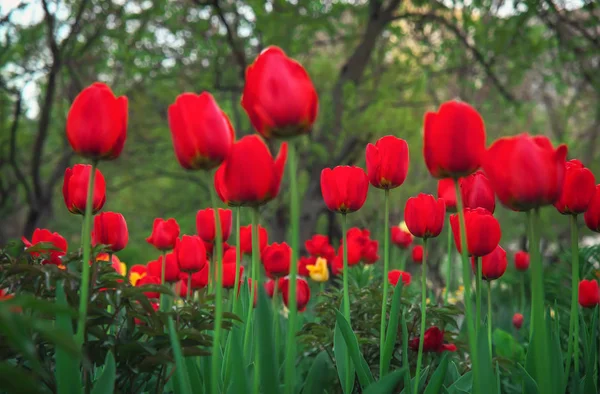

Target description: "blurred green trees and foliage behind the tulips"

left=0, top=0, right=600, bottom=272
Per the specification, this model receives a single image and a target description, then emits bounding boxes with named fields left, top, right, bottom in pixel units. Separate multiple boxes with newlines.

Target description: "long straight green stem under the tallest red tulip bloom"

left=284, top=142, right=300, bottom=394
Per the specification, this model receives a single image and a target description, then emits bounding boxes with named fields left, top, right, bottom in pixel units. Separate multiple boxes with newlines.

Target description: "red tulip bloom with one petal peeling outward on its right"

left=215, top=135, right=287, bottom=207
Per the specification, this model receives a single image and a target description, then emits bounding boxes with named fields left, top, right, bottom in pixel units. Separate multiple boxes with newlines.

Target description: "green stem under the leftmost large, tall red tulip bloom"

left=75, top=160, right=98, bottom=346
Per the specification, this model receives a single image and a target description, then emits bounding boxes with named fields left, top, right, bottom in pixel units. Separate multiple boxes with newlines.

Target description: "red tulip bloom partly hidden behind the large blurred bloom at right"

left=554, top=160, right=596, bottom=215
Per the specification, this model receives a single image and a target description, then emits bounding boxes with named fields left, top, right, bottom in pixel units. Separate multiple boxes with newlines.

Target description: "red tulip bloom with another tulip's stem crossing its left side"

left=450, top=208, right=502, bottom=257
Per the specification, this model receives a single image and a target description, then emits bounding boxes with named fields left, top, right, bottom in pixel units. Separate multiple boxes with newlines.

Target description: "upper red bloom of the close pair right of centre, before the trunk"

left=366, top=135, right=408, bottom=189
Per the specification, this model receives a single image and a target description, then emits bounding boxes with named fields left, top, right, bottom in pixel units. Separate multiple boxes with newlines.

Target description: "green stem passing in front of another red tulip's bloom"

left=454, top=179, right=483, bottom=394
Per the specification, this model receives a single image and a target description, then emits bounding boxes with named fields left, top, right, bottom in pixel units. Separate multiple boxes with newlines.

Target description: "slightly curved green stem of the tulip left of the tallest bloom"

left=207, top=176, right=223, bottom=394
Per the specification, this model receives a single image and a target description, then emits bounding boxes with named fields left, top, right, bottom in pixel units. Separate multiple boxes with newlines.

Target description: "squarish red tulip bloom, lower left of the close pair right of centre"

left=321, top=166, right=369, bottom=213
